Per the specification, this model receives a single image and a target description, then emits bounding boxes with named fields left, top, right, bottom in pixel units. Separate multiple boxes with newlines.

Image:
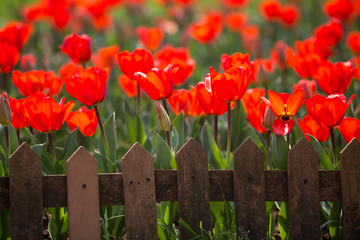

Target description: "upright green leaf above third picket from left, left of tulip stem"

left=124, top=101, right=146, bottom=145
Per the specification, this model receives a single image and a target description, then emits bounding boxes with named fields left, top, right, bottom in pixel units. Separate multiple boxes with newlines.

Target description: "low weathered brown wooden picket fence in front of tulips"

left=0, top=138, right=360, bottom=239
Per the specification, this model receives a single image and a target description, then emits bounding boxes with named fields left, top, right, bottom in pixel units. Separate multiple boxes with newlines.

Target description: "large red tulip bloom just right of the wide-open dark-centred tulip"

left=305, top=94, right=355, bottom=128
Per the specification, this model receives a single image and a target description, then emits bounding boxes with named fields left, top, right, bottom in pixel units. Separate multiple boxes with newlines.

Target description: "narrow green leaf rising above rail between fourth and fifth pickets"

left=201, top=120, right=226, bottom=170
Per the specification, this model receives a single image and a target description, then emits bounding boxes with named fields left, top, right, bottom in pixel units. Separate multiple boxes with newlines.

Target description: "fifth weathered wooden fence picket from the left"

left=233, top=138, right=266, bottom=239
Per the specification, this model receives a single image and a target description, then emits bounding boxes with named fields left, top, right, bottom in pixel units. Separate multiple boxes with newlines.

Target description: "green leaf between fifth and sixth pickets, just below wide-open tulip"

left=271, top=134, right=289, bottom=170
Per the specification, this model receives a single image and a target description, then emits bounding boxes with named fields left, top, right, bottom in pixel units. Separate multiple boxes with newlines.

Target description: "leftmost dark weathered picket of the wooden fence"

left=9, top=143, right=43, bottom=240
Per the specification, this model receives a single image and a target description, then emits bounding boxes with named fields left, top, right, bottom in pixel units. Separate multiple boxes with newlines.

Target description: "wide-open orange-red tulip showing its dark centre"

left=260, top=89, right=303, bottom=136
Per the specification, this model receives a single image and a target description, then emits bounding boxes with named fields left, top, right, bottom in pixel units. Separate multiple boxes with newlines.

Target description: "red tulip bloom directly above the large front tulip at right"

left=314, top=60, right=354, bottom=95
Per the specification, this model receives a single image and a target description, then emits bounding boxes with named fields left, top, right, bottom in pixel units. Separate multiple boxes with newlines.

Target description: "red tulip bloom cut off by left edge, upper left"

left=0, top=39, right=20, bottom=74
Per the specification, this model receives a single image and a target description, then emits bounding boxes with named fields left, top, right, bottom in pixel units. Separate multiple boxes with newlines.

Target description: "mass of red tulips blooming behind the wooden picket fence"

left=0, top=0, right=360, bottom=238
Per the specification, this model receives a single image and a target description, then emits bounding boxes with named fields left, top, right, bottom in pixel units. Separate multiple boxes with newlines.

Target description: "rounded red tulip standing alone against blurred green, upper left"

left=60, top=33, right=91, bottom=63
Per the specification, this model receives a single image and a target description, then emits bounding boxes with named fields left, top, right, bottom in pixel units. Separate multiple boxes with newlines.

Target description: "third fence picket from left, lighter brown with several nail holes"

left=122, top=143, right=158, bottom=240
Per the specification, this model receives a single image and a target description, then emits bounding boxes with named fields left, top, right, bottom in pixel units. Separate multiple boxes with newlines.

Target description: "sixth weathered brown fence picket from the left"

left=288, top=138, right=320, bottom=240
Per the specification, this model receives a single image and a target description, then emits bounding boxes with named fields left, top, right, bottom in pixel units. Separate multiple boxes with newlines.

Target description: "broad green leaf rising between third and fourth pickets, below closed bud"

left=151, top=132, right=176, bottom=169
